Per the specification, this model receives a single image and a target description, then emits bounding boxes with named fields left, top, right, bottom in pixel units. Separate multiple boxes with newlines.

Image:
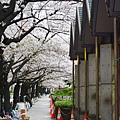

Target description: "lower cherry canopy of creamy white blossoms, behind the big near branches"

left=4, top=34, right=71, bottom=111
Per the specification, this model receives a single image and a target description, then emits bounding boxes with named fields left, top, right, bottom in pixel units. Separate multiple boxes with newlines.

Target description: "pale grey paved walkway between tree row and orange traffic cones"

left=27, top=96, right=51, bottom=120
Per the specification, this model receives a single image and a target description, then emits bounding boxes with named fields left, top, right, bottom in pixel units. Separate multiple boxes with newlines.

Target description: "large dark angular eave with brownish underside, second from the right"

left=90, top=0, right=114, bottom=36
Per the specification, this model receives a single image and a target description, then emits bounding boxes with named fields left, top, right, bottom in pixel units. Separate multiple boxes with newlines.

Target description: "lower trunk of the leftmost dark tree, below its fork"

left=4, top=82, right=11, bottom=112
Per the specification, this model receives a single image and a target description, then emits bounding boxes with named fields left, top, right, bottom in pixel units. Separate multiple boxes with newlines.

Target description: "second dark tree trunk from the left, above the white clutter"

left=13, top=83, right=20, bottom=109
